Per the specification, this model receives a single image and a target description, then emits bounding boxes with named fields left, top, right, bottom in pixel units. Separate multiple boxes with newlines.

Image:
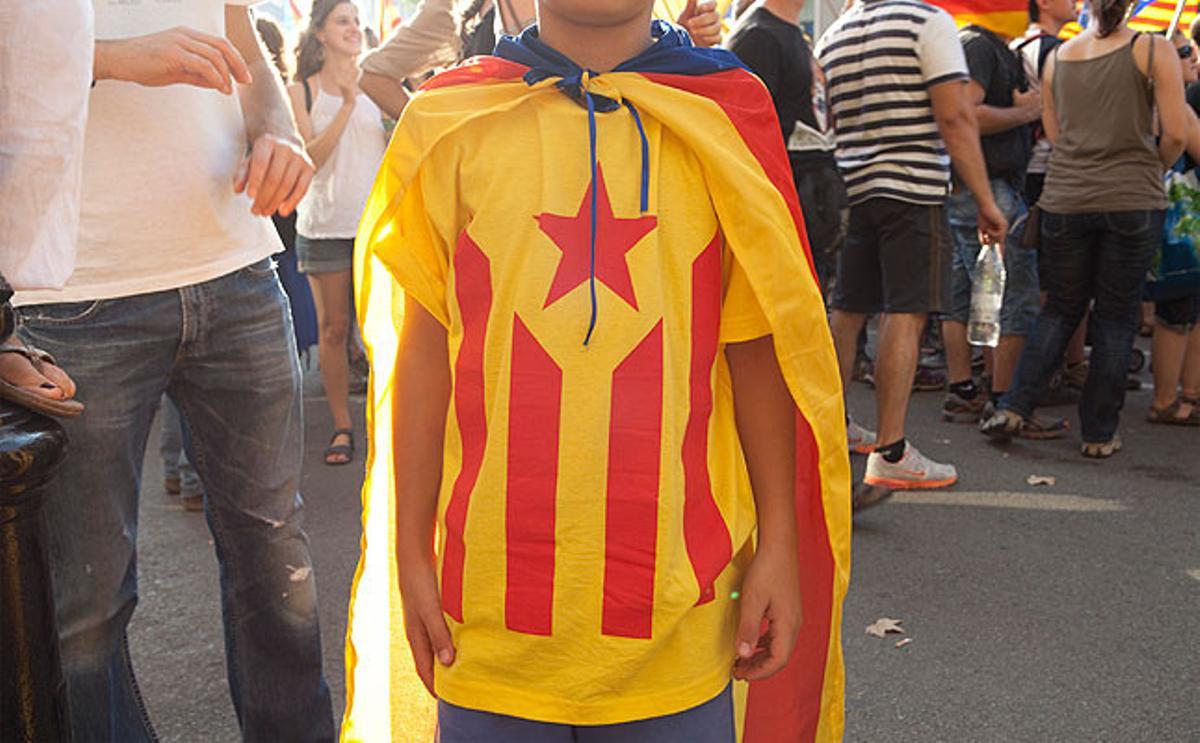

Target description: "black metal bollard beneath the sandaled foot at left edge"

left=0, top=401, right=71, bottom=742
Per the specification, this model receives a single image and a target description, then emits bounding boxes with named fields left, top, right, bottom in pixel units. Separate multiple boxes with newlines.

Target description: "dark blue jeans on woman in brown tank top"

left=997, top=209, right=1165, bottom=443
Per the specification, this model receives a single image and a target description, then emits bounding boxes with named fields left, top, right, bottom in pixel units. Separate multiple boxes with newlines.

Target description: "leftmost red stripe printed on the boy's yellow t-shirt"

left=442, top=230, right=492, bottom=622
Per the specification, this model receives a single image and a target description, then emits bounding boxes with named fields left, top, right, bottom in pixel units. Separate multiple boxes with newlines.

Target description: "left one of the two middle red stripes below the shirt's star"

left=504, top=317, right=563, bottom=635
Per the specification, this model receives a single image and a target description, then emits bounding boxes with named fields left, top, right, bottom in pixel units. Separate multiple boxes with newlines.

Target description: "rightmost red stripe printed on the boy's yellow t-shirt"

left=683, top=234, right=733, bottom=604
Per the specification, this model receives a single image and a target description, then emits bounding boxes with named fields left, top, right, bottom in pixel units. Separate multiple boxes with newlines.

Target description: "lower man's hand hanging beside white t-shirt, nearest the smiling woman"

left=233, top=134, right=313, bottom=217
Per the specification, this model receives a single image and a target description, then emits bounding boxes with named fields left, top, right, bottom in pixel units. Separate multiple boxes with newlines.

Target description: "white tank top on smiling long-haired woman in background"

left=296, top=80, right=388, bottom=239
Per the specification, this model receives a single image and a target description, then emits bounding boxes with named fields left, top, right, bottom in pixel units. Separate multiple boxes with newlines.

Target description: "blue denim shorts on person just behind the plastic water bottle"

left=946, top=179, right=1039, bottom=336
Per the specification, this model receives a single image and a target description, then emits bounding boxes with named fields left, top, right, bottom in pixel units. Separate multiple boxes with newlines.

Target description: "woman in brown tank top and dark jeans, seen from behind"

left=982, top=0, right=1188, bottom=457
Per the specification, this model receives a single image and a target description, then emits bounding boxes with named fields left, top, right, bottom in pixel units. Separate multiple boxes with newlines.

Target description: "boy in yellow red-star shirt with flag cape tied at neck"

left=349, top=0, right=848, bottom=743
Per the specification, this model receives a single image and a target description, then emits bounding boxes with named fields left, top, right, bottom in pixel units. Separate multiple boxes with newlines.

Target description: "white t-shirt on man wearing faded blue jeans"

left=16, top=0, right=282, bottom=305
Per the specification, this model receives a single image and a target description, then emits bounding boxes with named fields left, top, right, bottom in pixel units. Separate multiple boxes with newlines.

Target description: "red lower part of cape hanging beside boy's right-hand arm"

left=743, top=411, right=834, bottom=743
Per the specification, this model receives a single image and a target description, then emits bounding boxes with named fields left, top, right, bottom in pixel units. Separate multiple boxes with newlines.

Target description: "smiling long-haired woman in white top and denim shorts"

left=288, top=0, right=388, bottom=465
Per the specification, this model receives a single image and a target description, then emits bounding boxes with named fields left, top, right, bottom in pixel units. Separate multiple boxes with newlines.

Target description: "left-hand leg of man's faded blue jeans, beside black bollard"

left=20, top=292, right=181, bottom=743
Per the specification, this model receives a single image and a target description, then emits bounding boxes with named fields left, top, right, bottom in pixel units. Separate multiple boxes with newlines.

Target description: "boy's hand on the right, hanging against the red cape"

left=733, top=545, right=802, bottom=681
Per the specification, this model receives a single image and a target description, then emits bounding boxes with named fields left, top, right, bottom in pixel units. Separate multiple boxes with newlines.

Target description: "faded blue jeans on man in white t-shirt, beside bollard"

left=20, top=259, right=335, bottom=743
